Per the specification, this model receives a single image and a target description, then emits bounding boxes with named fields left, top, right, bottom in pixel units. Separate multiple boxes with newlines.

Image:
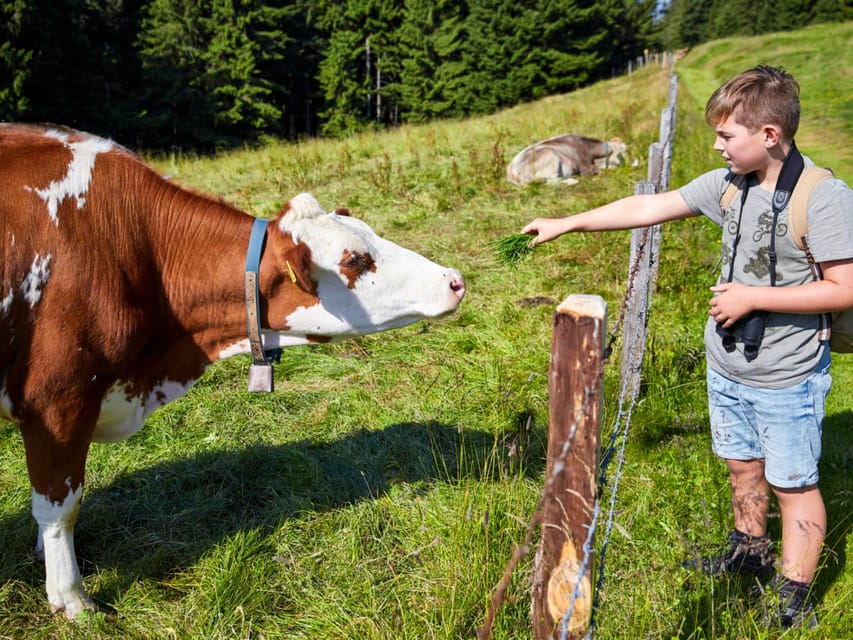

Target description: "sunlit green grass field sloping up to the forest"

left=0, top=23, right=853, bottom=640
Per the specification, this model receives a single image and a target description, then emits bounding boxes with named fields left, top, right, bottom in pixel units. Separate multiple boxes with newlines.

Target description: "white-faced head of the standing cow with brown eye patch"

left=270, top=193, right=465, bottom=342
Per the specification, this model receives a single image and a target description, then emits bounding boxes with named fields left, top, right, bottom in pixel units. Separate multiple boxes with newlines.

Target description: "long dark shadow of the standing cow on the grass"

left=0, top=423, right=544, bottom=598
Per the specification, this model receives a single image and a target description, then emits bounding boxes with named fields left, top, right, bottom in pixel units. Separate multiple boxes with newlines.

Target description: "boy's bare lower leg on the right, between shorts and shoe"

left=773, top=485, right=826, bottom=583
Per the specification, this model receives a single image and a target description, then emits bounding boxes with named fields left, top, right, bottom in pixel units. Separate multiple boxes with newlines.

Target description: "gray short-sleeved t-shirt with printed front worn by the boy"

left=679, top=159, right=853, bottom=389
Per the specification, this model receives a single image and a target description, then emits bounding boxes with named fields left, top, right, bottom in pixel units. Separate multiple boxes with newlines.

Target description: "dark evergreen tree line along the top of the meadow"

left=0, top=0, right=851, bottom=149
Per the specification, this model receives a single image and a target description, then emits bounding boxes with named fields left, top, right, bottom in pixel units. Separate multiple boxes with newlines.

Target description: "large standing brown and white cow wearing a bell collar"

left=0, top=124, right=465, bottom=618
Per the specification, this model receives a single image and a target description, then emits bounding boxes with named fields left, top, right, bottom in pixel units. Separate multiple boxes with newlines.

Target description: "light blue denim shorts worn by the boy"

left=707, top=348, right=832, bottom=489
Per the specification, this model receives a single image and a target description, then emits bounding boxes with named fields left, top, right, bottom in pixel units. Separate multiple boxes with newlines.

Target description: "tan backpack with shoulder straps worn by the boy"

left=720, top=166, right=853, bottom=353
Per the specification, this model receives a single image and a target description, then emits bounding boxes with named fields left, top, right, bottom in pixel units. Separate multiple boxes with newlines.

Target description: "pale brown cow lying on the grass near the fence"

left=506, top=135, right=627, bottom=187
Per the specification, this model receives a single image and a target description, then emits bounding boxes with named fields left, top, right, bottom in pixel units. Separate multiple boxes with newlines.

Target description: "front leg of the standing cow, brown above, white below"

left=22, top=428, right=96, bottom=618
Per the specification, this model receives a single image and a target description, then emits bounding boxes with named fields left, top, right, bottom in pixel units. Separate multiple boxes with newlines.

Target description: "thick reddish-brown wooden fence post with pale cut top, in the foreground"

left=531, top=295, right=607, bottom=640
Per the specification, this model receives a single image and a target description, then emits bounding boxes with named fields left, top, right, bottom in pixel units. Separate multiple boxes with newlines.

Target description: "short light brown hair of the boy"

left=705, top=64, right=800, bottom=140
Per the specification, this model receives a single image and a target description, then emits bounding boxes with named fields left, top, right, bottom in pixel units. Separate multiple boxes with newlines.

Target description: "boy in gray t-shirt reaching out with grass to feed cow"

left=522, top=65, right=853, bottom=628
